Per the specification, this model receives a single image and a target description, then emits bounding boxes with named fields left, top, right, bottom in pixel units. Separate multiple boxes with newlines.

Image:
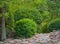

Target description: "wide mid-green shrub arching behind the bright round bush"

left=15, top=9, right=42, bottom=24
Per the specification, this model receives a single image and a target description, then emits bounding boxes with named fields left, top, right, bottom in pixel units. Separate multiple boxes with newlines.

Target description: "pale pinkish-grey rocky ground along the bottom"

left=0, top=30, right=60, bottom=44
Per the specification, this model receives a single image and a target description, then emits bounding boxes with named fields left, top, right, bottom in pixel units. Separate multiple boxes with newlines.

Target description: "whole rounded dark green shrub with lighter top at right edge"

left=47, top=18, right=60, bottom=32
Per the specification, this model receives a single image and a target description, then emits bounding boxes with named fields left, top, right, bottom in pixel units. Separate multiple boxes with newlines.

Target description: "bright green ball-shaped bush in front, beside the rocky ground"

left=15, top=19, right=37, bottom=38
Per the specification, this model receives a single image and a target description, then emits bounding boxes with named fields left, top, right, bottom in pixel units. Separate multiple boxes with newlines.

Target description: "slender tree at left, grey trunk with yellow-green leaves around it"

left=0, top=0, right=19, bottom=40
